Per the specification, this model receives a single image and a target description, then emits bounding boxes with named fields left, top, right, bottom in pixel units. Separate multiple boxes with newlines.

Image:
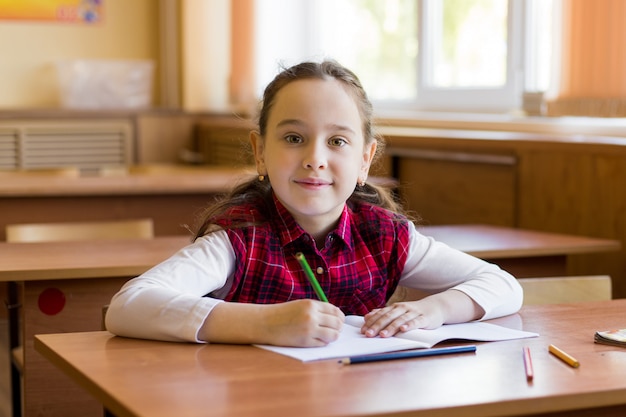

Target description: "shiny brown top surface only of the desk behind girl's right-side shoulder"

left=417, top=224, right=621, bottom=259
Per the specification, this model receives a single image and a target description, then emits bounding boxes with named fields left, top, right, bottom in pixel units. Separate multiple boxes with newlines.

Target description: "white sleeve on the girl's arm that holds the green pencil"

left=106, top=231, right=235, bottom=342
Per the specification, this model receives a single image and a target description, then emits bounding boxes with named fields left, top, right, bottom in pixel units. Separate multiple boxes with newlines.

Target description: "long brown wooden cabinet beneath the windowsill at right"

left=381, top=128, right=626, bottom=298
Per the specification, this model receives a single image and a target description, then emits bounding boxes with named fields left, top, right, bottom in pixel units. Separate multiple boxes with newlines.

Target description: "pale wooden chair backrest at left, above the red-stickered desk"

left=6, top=219, right=154, bottom=242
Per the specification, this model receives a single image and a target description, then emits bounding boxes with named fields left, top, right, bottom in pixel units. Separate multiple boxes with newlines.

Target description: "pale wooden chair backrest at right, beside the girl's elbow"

left=518, top=275, right=612, bottom=305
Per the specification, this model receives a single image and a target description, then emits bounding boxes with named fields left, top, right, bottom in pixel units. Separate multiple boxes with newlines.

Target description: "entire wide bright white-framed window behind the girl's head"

left=255, top=0, right=552, bottom=112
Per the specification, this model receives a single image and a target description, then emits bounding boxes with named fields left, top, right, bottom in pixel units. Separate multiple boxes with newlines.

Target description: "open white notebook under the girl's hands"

left=255, top=316, right=539, bottom=362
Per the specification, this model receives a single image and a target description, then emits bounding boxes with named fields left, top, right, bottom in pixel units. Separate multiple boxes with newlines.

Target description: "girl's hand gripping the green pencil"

left=262, top=299, right=345, bottom=347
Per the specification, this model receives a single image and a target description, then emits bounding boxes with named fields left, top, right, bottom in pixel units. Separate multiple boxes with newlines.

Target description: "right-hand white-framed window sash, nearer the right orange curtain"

left=417, top=0, right=522, bottom=111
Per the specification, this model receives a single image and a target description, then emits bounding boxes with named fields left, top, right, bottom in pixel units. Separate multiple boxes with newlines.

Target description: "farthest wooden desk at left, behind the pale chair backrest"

left=0, top=166, right=252, bottom=240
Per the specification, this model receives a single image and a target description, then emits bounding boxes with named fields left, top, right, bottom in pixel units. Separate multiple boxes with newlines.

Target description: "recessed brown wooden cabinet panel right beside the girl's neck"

left=392, top=149, right=517, bottom=226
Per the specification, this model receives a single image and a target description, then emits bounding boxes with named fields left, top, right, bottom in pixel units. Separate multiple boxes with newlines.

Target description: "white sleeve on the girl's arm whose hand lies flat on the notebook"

left=400, top=223, right=523, bottom=320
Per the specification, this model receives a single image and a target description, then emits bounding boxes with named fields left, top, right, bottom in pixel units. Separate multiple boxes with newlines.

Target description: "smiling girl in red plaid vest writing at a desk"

left=106, top=61, right=522, bottom=347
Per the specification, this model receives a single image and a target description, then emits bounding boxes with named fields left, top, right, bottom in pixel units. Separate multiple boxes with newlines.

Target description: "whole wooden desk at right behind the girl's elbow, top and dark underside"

left=418, top=224, right=621, bottom=278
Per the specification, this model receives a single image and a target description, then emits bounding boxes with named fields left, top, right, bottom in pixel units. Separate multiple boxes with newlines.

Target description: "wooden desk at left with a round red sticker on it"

left=0, top=236, right=190, bottom=416
